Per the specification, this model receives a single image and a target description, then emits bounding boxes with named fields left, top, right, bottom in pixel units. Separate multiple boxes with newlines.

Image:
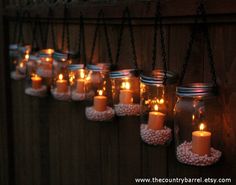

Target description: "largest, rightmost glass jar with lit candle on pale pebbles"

left=174, top=83, right=222, bottom=166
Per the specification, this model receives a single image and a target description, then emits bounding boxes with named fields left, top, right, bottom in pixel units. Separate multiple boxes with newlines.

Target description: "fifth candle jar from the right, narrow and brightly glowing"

left=68, top=64, right=87, bottom=101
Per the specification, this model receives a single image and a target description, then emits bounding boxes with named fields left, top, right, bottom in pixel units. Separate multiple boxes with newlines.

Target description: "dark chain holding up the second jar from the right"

left=152, top=0, right=168, bottom=84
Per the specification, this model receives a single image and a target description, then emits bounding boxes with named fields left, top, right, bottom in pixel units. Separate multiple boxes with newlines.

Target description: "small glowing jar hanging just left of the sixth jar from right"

left=37, top=49, right=54, bottom=79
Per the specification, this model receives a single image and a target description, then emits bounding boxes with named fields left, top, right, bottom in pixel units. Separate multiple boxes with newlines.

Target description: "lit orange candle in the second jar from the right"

left=148, top=104, right=165, bottom=130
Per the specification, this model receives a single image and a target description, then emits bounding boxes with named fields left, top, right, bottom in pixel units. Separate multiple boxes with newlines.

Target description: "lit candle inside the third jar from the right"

left=119, top=82, right=133, bottom=104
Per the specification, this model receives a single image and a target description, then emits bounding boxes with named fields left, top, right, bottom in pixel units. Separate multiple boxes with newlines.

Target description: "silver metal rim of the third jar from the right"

left=110, top=69, right=139, bottom=78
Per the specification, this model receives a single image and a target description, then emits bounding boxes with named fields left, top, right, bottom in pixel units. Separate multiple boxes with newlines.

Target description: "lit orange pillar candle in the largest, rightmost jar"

left=192, top=123, right=211, bottom=156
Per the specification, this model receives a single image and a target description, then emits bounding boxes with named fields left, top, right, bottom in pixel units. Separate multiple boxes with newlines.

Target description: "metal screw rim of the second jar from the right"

left=140, top=69, right=178, bottom=85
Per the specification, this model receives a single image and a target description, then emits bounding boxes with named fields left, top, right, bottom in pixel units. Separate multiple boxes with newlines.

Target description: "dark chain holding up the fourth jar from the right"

left=89, top=10, right=113, bottom=64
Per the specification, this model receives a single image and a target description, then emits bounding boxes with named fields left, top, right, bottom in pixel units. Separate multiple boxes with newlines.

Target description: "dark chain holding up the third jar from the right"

left=115, top=7, right=138, bottom=69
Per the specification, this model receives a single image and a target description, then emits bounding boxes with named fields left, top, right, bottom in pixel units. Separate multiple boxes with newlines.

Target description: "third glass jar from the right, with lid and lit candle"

left=110, top=69, right=140, bottom=116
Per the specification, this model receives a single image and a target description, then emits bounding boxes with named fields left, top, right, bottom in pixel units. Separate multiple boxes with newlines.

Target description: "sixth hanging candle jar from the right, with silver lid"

left=51, top=52, right=71, bottom=100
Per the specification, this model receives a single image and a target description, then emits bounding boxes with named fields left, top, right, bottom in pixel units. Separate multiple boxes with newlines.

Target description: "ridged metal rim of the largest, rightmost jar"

left=176, top=83, right=216, bottom=97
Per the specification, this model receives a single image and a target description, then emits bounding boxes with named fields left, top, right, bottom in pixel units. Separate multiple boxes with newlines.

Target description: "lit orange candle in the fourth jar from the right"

left=93, top=90, right=107, bottom=112
